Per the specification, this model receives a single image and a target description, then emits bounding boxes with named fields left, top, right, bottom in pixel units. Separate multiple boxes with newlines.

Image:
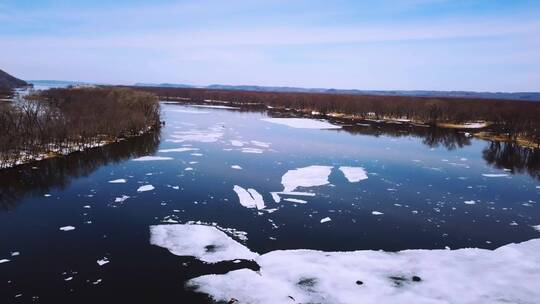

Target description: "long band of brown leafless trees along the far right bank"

left=131, top=87, right=540, bottom=143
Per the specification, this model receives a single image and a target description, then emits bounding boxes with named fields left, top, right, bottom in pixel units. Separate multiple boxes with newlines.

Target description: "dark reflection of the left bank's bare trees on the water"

left=0, top=132, right=160, bottom=210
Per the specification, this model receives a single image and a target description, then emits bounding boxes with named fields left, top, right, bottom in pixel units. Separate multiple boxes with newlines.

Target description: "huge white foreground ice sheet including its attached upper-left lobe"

left=174, top=225, right=540, bottom=304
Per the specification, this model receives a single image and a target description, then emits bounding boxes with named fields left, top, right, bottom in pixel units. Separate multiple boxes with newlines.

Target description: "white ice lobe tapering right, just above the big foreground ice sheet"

left=150, top=224, right=258, bottom=263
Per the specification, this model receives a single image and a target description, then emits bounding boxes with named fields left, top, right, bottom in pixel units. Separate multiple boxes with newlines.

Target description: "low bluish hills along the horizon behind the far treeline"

left=135, top=83, right=540, bottom=101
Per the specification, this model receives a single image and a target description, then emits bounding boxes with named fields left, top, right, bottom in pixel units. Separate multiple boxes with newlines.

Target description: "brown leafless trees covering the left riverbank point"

left=0, top=88, right=160, bottom=168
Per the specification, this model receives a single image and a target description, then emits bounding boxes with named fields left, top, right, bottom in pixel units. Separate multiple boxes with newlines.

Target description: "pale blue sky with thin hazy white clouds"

left=0, top=0, right=540, bottom=91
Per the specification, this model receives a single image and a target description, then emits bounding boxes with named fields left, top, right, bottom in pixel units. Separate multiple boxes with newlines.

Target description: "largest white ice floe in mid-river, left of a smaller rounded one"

left=281, top=166, right=332, bottom=192
